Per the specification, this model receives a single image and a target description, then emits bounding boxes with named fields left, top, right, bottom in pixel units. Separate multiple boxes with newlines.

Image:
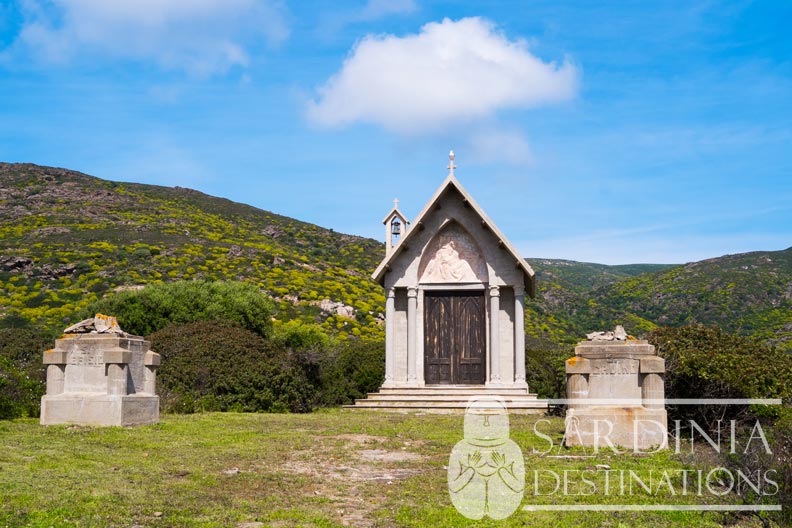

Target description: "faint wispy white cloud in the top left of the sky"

left=7, top=0, right=288, bottom=75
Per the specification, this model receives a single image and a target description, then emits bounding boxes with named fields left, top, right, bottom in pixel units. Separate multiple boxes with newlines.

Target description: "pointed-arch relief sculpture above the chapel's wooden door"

left=418, top=222, right=488, bottom=284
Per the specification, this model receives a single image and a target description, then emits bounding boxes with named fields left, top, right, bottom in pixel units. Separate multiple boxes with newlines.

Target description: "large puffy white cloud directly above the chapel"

left=308, top=18, right=579, bottom=133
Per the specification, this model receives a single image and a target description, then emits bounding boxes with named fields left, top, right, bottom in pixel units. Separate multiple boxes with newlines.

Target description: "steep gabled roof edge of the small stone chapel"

left=371, top=173, right=536, bottom=297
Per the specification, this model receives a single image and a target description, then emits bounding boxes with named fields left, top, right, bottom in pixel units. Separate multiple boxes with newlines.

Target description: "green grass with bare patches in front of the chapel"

left=0, top=410, right=759, bottom=527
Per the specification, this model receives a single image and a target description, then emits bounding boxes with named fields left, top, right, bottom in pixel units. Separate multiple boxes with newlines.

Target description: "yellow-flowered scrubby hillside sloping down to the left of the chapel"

left=0, top=163, right=385, bottom=336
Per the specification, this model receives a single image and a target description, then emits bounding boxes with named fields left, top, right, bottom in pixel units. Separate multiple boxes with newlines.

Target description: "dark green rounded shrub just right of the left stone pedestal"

left=149, top=321, right=315, bottom=413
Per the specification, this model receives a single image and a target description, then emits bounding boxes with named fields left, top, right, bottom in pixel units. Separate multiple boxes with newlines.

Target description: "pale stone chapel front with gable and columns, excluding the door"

left=373, top=173, right=534, bottom=393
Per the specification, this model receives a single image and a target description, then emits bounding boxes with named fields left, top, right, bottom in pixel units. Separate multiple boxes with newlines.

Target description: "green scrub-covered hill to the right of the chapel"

left=527, top=248, right=792, bottom=350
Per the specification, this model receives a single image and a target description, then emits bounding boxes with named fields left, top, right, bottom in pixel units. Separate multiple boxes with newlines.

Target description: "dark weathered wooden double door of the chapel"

left=424, top=291, right=487, bottom=385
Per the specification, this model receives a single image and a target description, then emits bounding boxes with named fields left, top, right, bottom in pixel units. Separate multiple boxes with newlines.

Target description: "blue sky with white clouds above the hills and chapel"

left=0, top=0, right=792, bottom=264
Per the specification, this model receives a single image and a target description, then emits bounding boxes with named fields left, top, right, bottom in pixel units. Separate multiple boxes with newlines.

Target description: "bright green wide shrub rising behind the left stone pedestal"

left=81, top=281, right=275, bottom=337
